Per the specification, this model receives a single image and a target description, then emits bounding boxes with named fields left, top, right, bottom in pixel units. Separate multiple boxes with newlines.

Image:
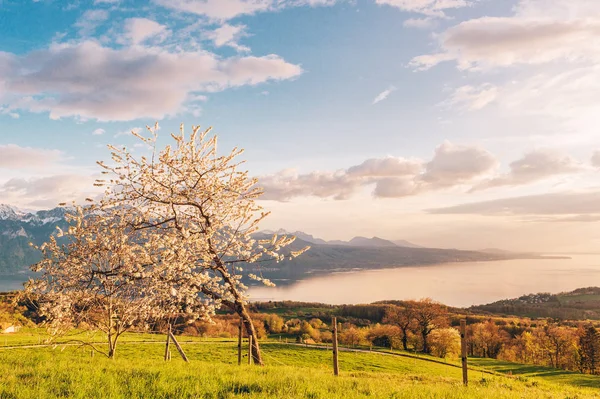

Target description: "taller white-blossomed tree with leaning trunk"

left=97, top=125, right=306, bottom=365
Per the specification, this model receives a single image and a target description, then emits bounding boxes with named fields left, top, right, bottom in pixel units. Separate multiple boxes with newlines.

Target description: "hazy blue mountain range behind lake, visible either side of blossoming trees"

left=0, top=205, right=552, bottom=284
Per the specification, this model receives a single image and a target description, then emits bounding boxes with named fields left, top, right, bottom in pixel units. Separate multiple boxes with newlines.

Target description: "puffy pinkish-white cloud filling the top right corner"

left=411, top=0, right=600, bottom=69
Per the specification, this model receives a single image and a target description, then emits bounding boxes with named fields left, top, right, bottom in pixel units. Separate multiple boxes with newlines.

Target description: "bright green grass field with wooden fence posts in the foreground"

left=0, top=330, right=600, bottom=399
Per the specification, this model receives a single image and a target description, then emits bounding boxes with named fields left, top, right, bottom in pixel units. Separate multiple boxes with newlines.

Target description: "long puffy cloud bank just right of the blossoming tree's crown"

left=259, top=142, right=497, bottom=201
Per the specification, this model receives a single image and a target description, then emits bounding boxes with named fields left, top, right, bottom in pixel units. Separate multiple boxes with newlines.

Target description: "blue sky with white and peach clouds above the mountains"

left=0, top=0, right=600, bottom=252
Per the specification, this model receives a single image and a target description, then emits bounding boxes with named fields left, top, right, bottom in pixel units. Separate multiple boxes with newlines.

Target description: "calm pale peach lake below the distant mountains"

left=249, top=254, right=600, bottom=307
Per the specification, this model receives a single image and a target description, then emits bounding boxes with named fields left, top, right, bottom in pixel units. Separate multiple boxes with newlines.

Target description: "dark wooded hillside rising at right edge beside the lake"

left=469, top=287, right=600, bottom=320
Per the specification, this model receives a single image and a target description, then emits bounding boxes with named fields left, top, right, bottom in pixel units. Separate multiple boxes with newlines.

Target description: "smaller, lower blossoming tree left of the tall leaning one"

left=25, top=206, right=210, bottom=358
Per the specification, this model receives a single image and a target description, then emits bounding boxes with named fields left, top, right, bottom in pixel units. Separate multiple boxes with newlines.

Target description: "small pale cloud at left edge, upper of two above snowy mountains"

left=0, top=144, right=63, bottom=170
